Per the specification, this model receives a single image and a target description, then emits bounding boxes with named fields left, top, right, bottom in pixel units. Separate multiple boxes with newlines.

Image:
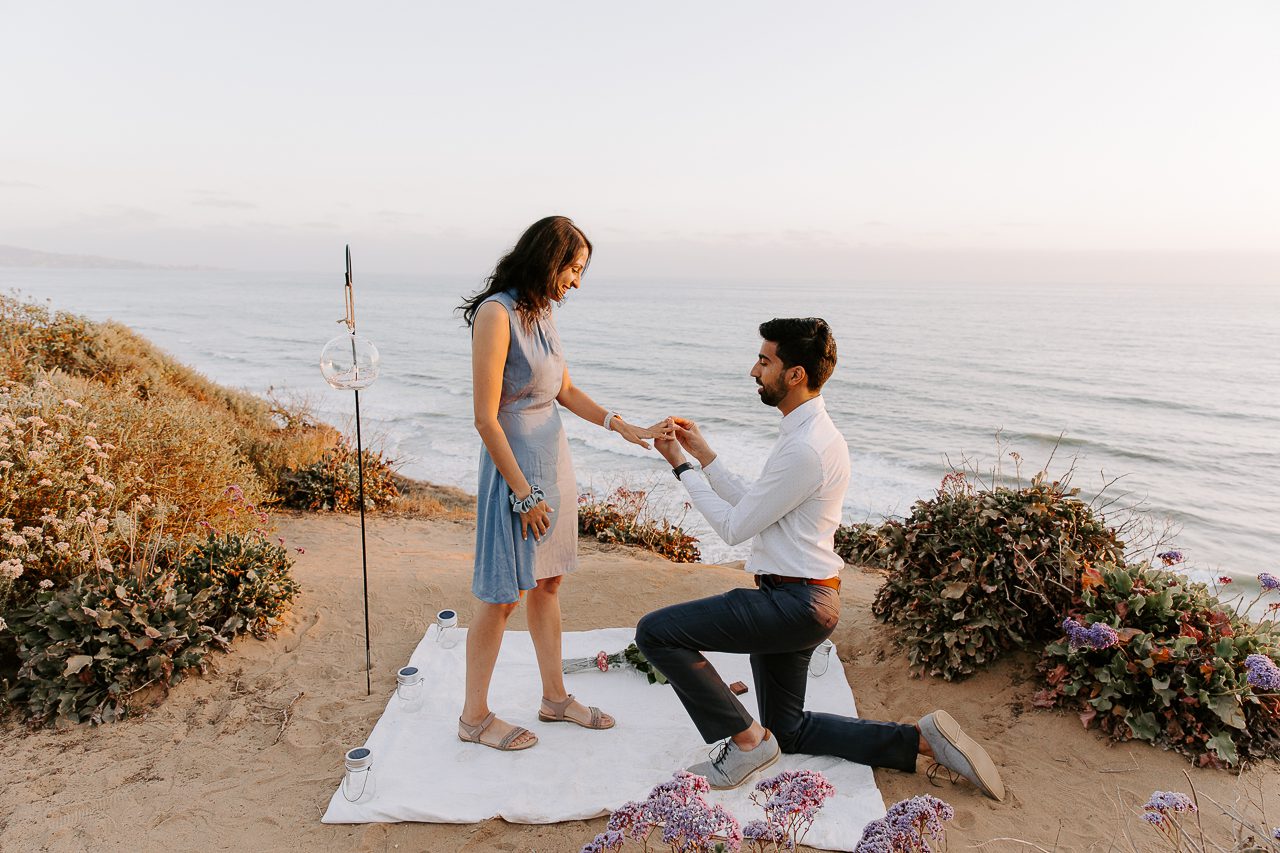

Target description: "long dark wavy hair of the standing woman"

left=458, top=216, right=591, bottom=327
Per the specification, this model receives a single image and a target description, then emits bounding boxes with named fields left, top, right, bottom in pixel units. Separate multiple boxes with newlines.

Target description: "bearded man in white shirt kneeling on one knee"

left=636, top=318, right=1005, bottom=800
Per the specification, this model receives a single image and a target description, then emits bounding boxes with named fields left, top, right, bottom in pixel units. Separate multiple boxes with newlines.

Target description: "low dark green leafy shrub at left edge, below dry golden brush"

left=5, top=573, right=220, bottom=724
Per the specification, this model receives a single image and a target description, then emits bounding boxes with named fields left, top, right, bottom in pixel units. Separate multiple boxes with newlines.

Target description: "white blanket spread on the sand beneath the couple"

left=324, top=625, right=884, bottom=850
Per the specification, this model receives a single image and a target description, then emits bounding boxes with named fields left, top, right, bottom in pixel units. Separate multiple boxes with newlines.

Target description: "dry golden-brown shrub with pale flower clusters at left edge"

left=0, top=373, right=266, bottom=593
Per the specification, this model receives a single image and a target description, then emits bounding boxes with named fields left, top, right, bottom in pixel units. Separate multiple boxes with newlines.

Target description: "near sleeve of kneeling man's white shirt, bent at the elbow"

left=680, top=444, right=822, bottom=546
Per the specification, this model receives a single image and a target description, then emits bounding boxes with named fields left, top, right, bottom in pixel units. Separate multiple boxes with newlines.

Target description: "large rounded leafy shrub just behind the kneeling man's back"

left=860, top=471, right=1123, bottom=680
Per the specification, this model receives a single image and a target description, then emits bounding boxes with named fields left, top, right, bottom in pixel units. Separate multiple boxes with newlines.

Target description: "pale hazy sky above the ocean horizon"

left=0, top=0, right=1280, bottom=283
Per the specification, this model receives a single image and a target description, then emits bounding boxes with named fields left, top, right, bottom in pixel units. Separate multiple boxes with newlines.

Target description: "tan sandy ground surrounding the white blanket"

left=0, top=515, right=1280, bottom=853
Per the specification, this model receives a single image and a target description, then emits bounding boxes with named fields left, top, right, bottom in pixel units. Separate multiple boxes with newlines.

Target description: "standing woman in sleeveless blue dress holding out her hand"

left=458, top=216, right=663, bottom=751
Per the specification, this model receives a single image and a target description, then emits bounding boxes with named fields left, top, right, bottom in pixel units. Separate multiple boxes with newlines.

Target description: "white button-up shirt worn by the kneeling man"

left=680, top=394, right=849, bottom=578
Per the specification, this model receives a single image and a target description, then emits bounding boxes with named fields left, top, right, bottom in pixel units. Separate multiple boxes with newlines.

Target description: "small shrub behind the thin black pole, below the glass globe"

left=278, top=442, right=399, bottom=512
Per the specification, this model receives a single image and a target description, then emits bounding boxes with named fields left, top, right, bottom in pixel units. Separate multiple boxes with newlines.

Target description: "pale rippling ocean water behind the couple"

left=0, top=268, right=1280, bottom=578
